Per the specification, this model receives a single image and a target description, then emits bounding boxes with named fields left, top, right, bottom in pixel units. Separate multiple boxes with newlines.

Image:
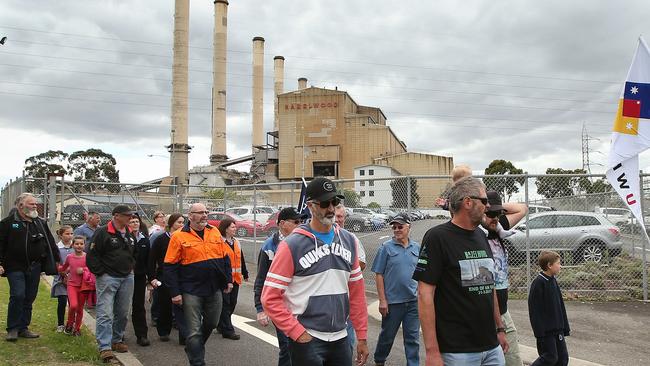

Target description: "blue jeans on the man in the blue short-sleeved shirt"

left=374, top=301, right=420, bottom=366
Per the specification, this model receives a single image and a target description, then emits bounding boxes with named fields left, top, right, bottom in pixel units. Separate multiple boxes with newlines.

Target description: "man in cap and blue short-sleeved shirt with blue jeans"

left=372, top=214, right=420, bottom=366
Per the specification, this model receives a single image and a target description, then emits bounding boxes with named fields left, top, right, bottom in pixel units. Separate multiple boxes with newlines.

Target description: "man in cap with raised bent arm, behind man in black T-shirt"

left=481, top=191, right=528, bottom=366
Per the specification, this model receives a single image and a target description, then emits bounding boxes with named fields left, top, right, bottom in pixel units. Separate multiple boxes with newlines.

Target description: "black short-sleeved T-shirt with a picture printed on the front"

left=413, top=221, right=499, bottom=353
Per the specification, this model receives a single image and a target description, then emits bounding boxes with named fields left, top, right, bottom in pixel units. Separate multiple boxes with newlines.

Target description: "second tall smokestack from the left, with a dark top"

left=210, top=0, right=228, bottom=163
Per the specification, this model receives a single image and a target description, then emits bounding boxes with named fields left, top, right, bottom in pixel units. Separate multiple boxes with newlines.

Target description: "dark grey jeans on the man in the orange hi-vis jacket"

left=183, top=291, right=223, bottom=366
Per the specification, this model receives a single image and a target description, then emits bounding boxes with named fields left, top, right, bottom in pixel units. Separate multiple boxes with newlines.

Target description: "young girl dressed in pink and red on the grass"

left=61, top=235, right=87, bottom=336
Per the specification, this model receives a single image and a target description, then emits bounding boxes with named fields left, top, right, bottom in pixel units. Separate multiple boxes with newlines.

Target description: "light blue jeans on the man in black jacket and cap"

left=95, top=273, right=133, bottom=352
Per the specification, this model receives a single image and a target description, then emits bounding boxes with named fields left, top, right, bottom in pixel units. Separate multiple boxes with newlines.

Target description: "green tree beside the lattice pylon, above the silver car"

left=535, top=168, right=592, bottom=198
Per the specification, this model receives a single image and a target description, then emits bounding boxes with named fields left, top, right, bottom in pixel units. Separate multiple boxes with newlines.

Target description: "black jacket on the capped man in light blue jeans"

left=86, top=221, right=136, bottom=277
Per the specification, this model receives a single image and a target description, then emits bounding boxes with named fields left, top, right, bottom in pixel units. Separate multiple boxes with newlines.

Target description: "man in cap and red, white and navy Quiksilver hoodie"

left=262, top=177, right=368, bottom=366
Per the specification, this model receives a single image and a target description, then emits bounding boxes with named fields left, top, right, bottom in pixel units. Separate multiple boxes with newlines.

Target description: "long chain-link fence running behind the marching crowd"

left=2, top=173, right=650, bottom=300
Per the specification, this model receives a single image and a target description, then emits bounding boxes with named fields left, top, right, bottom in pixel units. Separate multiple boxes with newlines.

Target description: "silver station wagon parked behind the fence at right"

left=505, top=211, right=623, bottom=263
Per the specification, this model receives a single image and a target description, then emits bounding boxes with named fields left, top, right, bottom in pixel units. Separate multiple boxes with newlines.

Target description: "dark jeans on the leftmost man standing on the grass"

left=7, top=263, right=41, bottom=331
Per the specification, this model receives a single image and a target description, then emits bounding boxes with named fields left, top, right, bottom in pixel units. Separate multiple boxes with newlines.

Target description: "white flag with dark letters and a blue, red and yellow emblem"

left=607, top=37, right=650, bottom=225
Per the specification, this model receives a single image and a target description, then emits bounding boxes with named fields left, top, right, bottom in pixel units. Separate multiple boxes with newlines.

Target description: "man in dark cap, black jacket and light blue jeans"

left=86, top=205, right=136, bottom=363
